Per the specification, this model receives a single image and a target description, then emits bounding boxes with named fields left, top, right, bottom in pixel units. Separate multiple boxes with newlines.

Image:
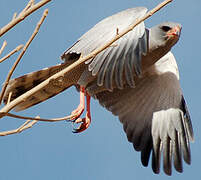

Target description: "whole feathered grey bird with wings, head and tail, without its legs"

left=1, top=7, right=193, bottom=175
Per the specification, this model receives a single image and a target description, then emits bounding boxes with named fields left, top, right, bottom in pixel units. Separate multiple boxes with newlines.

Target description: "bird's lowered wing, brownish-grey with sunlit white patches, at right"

left=95, top=52, right=193, bottom=175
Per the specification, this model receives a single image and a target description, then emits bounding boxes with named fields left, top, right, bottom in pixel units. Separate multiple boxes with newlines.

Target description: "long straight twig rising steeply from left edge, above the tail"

left=0, top=9, right=48, bottom=104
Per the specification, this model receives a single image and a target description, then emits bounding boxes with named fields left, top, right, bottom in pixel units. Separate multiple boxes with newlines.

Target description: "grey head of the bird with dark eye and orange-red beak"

left=151, top=22, right=181, bottom=47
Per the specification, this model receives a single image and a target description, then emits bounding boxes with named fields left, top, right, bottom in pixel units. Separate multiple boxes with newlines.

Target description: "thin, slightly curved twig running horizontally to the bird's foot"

left=6, top=113, right=75, bottom=122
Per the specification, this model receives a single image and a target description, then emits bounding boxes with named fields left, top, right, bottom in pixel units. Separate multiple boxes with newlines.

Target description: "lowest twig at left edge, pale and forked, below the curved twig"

left=0, top=116, right=40, bottom=136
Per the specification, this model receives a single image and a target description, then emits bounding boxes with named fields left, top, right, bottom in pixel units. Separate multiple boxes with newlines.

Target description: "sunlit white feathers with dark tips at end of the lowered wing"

left=152, top=108, right=191, bottom=175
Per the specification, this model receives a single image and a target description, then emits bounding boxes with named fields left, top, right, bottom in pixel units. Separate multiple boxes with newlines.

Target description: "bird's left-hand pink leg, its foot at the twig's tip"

left=71, top=86, right=85, bottom=120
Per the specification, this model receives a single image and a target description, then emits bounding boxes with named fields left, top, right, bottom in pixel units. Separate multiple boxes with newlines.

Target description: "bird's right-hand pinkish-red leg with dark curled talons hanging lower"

left=73, top=92, right=91, bottom=133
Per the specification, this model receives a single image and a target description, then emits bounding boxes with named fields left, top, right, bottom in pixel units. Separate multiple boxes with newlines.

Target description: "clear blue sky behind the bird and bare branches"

left=0, top=0, right=201, bottom=180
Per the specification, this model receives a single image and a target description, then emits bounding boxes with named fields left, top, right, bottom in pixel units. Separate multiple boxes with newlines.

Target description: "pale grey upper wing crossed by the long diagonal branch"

left=62, top=7, right=147, bottom=90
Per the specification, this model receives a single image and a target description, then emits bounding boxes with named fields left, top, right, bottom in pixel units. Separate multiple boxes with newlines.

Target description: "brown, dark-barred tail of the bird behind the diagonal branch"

left=3, top=63, right=79, bottom=111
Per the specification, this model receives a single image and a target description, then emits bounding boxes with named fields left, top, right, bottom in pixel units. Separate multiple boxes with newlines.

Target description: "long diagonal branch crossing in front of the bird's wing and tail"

left=0, top=0, right=172, bottom=118
